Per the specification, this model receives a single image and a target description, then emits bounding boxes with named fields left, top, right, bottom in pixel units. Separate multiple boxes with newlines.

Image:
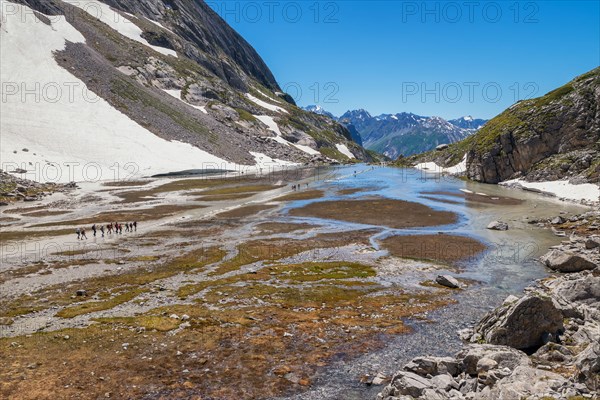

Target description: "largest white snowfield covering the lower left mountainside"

left=0, top=1, right=246, bottom=182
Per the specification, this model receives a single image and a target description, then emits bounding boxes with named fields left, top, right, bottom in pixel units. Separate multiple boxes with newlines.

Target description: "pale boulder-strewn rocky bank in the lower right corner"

left=377, top=211, right=600, bottom=400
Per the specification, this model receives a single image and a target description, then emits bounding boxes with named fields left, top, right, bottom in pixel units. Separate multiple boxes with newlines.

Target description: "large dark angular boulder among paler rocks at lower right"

left=475, top=293, right=563, bottom=349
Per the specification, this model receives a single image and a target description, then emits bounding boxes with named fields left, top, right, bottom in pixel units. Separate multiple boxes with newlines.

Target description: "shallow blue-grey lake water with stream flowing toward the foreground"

left=270, top=165, right=585, bottom=400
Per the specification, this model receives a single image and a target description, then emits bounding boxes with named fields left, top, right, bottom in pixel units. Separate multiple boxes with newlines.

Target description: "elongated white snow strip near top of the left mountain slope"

left=64, top=0, right=177, bottom=57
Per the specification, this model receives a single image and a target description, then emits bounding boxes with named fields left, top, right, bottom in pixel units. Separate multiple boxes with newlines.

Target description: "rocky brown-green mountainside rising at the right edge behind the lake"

left=411, top=68, right=600, bottom=184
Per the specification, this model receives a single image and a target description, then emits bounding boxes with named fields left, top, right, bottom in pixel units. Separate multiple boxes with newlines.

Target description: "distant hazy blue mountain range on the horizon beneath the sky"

left=307, top=106, right=486, bottom=159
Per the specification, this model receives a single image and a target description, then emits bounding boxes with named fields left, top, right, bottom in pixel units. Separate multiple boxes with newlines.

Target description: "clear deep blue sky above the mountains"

left=206, top=0, right=600, bottom=119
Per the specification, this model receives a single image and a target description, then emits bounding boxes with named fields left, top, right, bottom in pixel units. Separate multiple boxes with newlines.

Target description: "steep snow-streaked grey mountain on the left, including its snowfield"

left=0, top=0, right=370, bottom=180
